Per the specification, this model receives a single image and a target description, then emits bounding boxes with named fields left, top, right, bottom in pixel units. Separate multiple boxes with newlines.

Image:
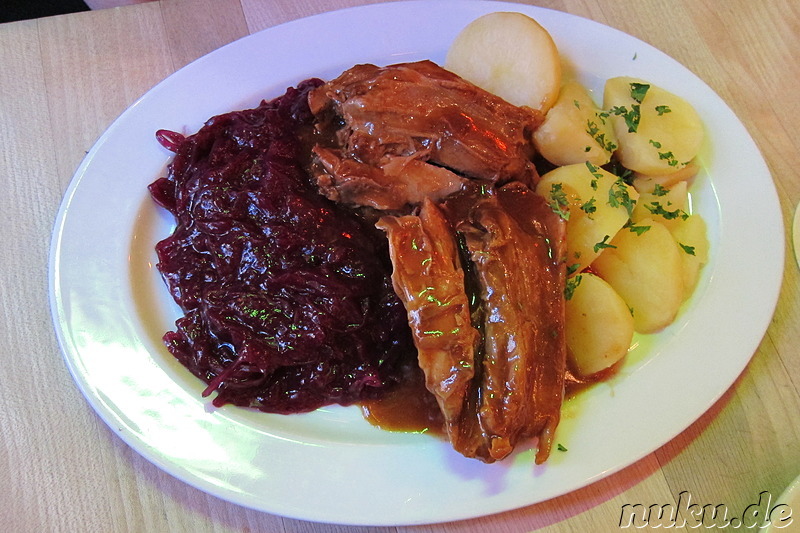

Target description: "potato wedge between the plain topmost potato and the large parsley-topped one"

left=533, top=81, right=617, bottom=166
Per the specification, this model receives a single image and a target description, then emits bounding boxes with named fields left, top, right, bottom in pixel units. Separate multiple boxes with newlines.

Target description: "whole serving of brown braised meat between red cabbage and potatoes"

left=309, top=61, right=566, bottom=463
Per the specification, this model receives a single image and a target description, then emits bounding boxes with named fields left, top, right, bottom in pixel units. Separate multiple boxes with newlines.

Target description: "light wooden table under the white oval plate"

left=0, top=0, right=800, bottom=533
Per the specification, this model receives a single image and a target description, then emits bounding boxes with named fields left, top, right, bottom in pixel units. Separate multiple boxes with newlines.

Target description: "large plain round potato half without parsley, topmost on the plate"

left=445, top=12, right=561, bottom=113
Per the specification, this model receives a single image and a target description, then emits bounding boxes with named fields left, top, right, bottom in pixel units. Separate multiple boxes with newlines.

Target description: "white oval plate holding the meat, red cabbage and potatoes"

left=50, top=1, right=784, bottom=525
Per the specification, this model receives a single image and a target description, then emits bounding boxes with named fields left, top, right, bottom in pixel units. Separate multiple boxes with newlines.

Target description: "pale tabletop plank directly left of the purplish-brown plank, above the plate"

left=38, top=2, right=175, bottom=186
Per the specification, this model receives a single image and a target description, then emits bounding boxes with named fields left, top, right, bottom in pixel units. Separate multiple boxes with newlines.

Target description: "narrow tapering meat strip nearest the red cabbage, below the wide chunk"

left=377, top=199, right=479, bottom=440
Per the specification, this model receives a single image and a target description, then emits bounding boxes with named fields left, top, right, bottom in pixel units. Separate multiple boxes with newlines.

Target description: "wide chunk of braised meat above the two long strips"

left=309, top=61, right=542, bottom=211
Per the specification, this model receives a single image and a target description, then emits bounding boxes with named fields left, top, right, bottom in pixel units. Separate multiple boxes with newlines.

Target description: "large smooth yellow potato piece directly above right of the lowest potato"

left=592, top=219, right=685, bottom=333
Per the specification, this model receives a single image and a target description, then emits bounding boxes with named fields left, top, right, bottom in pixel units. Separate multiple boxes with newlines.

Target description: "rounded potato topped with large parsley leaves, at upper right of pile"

left=603, top=77, right=704, bottom=176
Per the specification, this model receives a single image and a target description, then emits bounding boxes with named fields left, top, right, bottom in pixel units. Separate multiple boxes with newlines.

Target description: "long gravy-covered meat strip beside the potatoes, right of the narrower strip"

left=459, top=183, right=566, bottom=463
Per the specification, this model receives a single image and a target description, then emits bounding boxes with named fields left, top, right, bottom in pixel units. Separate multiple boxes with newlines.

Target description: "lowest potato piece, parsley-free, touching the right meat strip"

left=564, top=273, right=633, bottom=377
